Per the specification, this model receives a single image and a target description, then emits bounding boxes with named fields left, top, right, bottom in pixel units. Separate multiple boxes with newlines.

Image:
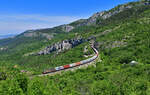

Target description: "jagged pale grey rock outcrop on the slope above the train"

left=35, top=38, right=86, bottom=55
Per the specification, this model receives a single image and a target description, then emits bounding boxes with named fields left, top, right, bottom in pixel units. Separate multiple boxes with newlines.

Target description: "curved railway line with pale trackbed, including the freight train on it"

left=38, top=45, right=99, bottom=76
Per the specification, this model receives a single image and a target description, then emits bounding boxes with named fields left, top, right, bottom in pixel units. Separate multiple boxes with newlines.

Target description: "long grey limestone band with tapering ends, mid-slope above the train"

left=24, top=36, right=95, bottom=56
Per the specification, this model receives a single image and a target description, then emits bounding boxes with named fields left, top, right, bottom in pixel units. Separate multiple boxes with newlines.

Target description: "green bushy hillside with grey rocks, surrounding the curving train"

left=0, top=1, right=150, bottom=95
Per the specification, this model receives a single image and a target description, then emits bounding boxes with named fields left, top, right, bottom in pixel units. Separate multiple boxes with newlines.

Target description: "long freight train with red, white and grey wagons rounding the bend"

left=42, top=46, right=98, bottom=74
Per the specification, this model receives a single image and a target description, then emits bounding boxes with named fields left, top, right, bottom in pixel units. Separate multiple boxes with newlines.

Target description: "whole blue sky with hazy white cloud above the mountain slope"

left=0, top=0, right=135, bottom=35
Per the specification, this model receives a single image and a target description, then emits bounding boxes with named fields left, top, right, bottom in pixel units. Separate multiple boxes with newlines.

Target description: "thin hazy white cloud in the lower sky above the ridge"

left=0, top=14, right=88, bottom=35
